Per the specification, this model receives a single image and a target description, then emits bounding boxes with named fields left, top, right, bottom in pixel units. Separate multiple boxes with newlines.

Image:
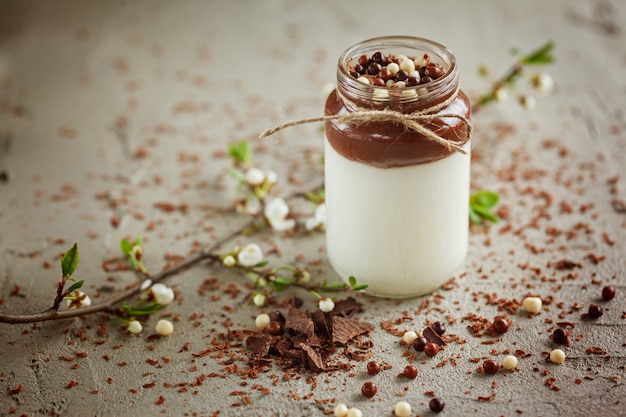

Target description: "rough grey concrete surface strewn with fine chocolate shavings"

left=0, top=0, right=626, bottom=417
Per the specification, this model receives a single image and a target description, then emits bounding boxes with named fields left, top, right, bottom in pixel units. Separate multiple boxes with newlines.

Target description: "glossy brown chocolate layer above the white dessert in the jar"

left=324, top=90, right=470, bottom=168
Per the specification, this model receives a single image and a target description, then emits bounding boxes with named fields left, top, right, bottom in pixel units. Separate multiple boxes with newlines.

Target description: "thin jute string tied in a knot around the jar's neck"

left=259, top=88, right=472, bottom=155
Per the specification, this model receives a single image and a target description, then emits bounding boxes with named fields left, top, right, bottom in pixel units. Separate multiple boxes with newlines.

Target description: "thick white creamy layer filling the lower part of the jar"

left=324, top=140, right=470, bottom=297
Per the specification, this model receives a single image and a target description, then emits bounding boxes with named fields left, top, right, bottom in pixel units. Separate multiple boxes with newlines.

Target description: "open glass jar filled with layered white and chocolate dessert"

left=324, top=36, right=471, bottom=297
